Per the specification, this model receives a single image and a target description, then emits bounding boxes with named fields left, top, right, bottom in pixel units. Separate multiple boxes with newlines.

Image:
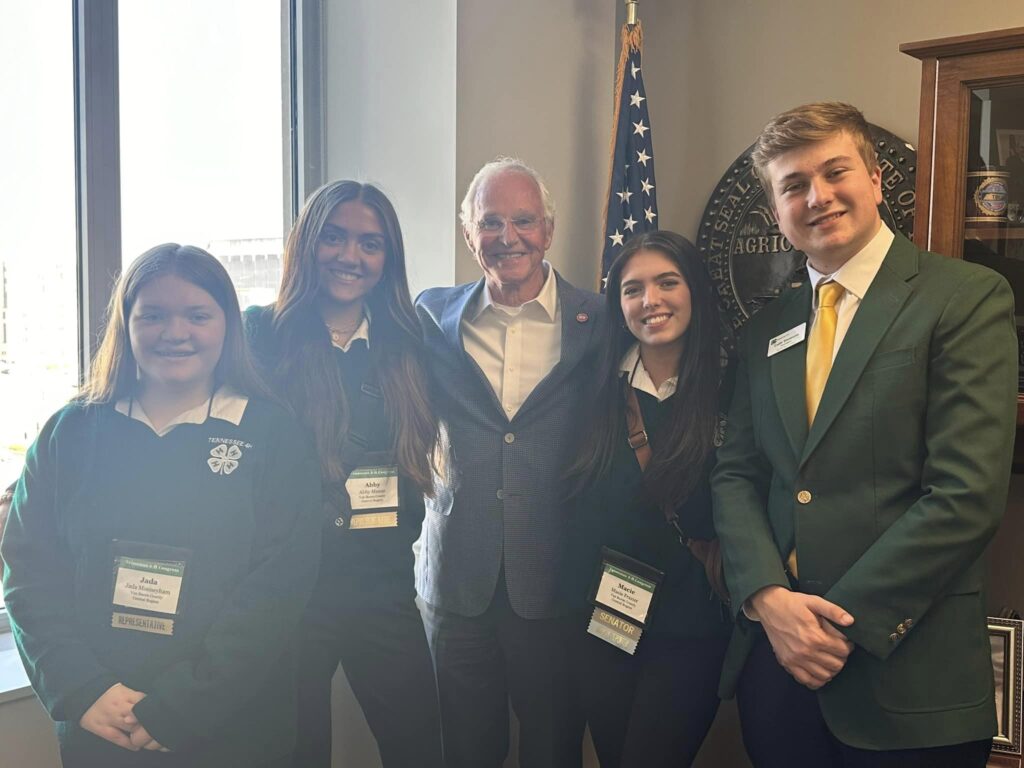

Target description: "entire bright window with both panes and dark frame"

left=0, top=0, right=323, bottom=631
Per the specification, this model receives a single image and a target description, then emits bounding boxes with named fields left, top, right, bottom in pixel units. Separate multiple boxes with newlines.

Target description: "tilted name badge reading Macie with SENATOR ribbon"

left=587, top=547, right=665, bottom=655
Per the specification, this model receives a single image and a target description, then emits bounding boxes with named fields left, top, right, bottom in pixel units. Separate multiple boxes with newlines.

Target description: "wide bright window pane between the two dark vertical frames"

left=118, top=0, right=286, bottom=307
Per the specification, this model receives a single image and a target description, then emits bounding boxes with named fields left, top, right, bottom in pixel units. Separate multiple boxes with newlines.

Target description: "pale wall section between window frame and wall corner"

left=324, top=0, right=457, bottom=294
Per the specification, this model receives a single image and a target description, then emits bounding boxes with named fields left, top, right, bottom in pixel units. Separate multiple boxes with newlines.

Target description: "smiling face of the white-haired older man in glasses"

left=463, top=171, right=554, bottom=304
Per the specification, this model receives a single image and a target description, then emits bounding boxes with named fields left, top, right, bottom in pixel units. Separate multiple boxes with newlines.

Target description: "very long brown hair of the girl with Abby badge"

left=271, top=181, right=437, bottom=494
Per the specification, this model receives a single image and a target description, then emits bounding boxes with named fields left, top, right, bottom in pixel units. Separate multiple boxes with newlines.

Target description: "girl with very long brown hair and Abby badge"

left=246, top=181, right=441, bottom=768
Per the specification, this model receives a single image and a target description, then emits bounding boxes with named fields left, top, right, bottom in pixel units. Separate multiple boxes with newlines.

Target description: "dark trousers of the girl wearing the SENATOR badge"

left=573, top=618, right=728, bottom=768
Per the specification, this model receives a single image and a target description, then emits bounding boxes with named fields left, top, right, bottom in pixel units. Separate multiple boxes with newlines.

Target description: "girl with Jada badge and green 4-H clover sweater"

left=3, top=243, right=321, bottom=768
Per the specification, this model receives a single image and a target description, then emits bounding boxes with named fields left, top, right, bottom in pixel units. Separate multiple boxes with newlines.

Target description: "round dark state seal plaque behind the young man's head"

left=697, top=125, right=918, bottom=329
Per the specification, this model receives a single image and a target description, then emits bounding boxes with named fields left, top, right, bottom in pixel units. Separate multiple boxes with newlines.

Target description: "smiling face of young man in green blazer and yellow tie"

left=766, top=131, right=882, bottom=274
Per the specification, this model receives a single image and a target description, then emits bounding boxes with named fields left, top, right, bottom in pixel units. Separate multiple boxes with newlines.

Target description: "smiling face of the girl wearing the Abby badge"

left=316, top=200, right=387, bottom=314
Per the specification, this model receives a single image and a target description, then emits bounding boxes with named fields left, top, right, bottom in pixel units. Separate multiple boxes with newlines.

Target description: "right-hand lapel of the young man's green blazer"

left=800, top=234, right=919, bottom=464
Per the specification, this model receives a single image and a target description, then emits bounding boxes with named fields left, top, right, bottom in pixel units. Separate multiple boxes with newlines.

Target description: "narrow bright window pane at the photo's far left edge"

left=0, top=0, right=79, bottom=487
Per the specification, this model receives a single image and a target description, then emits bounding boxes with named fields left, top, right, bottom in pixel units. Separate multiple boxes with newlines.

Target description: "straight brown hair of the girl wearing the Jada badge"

left=77, top=243, right=267, bottom=403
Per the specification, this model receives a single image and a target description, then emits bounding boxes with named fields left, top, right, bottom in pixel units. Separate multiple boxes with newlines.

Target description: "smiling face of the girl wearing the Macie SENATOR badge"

left=618, top=250, right=692, bottom=350
